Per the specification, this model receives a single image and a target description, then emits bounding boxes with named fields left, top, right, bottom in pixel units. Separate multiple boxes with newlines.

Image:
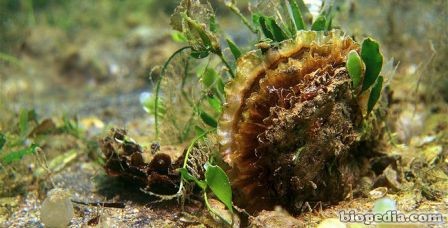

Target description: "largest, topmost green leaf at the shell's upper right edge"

left=361, top=38, right=383, bottom=92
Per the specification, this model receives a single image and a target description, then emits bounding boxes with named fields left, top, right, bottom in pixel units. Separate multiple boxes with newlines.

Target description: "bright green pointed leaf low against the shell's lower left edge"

left=205, top=163, right=233, bottom=213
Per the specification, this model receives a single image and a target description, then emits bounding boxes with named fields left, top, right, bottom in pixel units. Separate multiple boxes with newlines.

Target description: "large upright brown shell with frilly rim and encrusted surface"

left=218, top=31, right=362, bottom=211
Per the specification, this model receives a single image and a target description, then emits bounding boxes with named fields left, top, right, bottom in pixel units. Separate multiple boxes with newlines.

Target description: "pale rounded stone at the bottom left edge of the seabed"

left=40, top=188, right=74, bottom=227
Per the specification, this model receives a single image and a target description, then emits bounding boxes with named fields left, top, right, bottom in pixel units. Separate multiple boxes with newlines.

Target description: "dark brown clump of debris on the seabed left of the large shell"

left=101, top=129, right=182, bottom=194
